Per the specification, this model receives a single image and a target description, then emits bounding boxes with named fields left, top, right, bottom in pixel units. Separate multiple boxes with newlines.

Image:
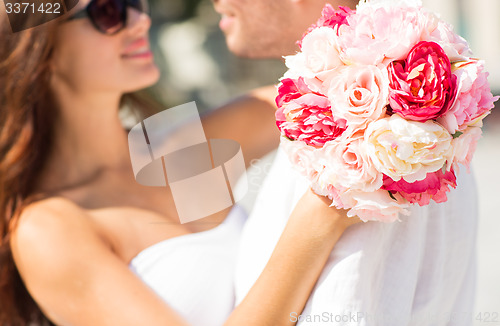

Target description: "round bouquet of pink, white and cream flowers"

left=276, top=0, right=498, bottom=222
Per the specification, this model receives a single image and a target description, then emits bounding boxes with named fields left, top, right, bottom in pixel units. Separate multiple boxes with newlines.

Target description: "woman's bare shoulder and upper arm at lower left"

left=10, top=198, right=188, bottom=326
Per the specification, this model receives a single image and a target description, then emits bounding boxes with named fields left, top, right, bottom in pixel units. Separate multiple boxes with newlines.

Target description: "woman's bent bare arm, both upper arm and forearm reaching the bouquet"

left=11, top=191, right=359, bottom=326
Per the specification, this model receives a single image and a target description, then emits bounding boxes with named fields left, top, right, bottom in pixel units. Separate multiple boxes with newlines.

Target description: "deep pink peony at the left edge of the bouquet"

left=276, top=78, right=346, bottom=147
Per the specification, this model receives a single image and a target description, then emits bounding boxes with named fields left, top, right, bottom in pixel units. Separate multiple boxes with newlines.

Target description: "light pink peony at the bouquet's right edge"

left=437, top=60, right=498, bottom=134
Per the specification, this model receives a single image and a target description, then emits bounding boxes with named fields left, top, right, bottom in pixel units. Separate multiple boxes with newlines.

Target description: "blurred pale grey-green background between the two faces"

left=143, top=0, right=285, bottom=111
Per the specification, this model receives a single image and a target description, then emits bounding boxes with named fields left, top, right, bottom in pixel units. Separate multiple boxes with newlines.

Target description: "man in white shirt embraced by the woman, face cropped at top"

left=210, top=0, right=477, bottom=326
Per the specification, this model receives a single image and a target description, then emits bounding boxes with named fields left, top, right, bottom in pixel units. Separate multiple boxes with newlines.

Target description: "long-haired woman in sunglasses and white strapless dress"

left=0, top=0, right=359, bottom=325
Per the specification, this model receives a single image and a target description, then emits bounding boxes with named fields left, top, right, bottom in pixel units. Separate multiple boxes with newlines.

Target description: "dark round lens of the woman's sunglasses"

left=88, top=0, right=126, bottom=34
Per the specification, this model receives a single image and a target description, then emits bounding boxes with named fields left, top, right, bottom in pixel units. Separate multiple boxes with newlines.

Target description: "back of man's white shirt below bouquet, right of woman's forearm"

left=291, top=169, right=478, bottom=326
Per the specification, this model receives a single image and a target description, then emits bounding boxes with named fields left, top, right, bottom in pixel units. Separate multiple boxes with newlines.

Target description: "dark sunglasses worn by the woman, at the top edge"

left=67, top=0, right=149, bottom=35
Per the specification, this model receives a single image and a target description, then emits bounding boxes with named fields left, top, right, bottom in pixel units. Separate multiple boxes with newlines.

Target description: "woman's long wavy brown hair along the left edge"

left=0, top=8, right=159, bottom=326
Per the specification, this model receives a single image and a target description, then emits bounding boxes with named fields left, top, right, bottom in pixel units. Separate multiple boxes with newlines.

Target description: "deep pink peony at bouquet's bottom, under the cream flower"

left=382, top=169, right=457, bottom=206
